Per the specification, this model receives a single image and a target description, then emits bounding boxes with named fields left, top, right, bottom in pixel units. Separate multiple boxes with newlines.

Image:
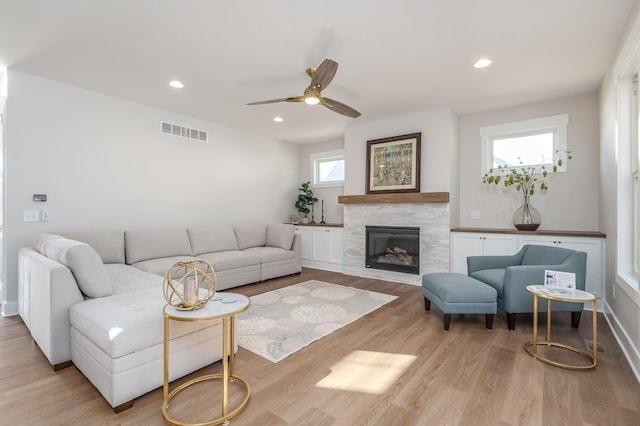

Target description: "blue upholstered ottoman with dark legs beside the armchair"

left=422, top=272, right=498, bottom=330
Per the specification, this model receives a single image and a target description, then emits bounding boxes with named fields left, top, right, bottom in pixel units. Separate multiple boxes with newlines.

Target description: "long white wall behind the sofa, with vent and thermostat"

left=3, top=71, right=300, bottom=313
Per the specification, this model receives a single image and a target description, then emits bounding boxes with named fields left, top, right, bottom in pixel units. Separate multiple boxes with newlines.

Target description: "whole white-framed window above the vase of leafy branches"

left=480, top=114, right=569, bottom=175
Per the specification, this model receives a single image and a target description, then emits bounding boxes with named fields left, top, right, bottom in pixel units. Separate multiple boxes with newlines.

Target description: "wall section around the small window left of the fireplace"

left=298, top=139, right=344, bottom=223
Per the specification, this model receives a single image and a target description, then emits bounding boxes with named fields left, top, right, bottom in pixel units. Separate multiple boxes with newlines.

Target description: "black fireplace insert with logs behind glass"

left=365, top=226, right=420, bottom=275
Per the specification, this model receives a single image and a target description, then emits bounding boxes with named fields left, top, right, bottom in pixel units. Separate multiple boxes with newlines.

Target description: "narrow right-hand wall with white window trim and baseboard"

left=600, top=3, right=640, bottom=380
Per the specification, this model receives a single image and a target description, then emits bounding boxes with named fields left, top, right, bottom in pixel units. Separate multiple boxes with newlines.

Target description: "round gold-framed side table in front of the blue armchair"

left=524, top=285, right=598, bottom=370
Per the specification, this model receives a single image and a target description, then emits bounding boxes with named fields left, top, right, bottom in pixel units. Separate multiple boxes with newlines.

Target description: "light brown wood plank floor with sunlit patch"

left=0, top=269, right=640, bottom=426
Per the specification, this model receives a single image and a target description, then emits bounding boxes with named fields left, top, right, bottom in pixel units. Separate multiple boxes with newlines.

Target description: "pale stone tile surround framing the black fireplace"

left=339, top=194, right=451, bottom=285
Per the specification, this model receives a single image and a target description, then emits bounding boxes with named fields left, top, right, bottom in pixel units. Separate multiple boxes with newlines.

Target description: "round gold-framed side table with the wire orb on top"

left=162, top=293, right=251, bottom=425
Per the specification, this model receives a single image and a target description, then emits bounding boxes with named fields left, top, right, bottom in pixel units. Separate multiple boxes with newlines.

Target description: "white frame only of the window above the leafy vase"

left=480, top=114, right=569, bottom=176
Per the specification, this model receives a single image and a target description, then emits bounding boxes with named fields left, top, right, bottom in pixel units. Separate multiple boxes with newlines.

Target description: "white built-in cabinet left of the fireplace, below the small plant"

left=296, top=225, right=344, bottom=272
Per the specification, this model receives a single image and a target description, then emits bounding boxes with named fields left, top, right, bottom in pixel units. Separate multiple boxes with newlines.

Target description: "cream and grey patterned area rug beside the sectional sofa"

left=236, top=280, right=397, bottom=362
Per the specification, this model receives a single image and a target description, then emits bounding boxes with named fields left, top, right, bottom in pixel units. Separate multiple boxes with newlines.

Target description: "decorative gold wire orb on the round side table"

left=162, top=260, right=216, bottom=311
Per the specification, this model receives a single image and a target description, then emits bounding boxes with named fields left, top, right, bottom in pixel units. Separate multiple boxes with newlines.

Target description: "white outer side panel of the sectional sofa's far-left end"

left=18, top=248, right=84, bottom=366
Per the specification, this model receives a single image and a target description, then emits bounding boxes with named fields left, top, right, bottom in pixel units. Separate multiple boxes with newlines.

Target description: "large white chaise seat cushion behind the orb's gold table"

left=69, top=287, right=211, bottom=358
